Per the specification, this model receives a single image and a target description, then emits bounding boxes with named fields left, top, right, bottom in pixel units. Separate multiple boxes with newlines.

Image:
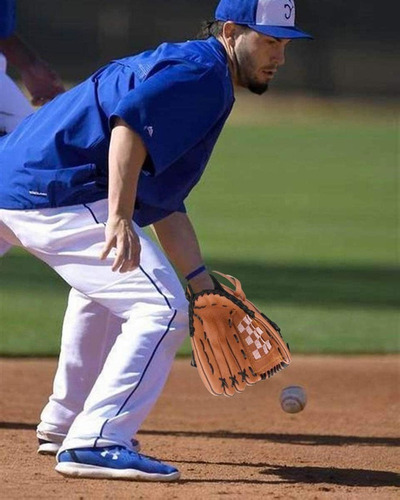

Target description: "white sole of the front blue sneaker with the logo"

left=55, top=462, right=181, bottom=481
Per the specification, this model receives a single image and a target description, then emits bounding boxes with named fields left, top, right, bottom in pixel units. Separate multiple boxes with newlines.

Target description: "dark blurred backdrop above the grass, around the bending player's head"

left=11, top=0, right=400, bottom=98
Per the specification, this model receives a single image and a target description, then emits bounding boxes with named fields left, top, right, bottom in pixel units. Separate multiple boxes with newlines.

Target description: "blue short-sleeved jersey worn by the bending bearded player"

left=0, top=38, right=234, bottom=226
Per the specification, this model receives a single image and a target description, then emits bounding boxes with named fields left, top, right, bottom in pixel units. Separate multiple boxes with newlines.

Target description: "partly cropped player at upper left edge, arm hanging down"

left=0, top=0, right=64, bottom=136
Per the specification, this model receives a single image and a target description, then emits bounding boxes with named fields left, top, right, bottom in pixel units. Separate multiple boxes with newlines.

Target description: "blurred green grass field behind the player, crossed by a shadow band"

left=0, top=96, right=400, bottom=356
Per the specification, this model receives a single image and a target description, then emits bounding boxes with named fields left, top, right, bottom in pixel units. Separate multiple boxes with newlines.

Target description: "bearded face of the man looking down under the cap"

left=235, top=29, right=290, bottom=95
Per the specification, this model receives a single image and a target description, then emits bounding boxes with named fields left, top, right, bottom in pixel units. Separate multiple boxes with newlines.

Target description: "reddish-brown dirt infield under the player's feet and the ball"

left=0, top=356, right=400, bottom=500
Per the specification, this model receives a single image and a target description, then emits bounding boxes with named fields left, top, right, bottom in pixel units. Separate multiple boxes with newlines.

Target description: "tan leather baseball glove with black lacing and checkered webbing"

left=186, top=271, right=291, bottom=396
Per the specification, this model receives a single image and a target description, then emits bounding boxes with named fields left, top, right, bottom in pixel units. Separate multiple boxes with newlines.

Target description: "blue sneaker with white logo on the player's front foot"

left=56, top=446, right=180, bottom=481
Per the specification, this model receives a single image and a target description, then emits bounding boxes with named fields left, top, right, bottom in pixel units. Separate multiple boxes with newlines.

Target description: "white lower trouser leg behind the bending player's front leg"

left=37, top=288, right=123, bottom=444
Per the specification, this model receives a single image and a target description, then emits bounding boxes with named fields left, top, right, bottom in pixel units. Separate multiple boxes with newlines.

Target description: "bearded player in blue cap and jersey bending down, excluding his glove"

left=0, top=0, right=310, bottom=481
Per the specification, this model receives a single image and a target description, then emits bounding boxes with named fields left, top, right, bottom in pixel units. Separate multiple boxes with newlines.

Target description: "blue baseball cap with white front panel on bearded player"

left=215, top=0, right=312, bottom=39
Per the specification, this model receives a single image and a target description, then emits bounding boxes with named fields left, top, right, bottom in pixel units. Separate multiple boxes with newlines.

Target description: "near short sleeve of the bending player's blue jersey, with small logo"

left=110, top=62, right=226, bottom=175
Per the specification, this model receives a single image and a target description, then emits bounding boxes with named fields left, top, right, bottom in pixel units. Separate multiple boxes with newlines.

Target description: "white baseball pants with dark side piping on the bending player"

left=0, top=200, right=188, bottom=449
